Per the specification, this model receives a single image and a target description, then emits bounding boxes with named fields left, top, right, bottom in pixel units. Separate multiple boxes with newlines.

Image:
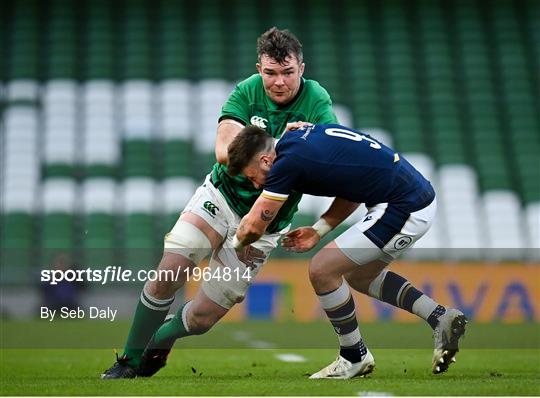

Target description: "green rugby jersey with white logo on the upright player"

left=212, top=74, right=337, bottom=233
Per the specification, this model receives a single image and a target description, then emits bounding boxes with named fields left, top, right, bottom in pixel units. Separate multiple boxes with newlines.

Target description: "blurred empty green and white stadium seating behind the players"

left=0, top=0, right=540, bottom=274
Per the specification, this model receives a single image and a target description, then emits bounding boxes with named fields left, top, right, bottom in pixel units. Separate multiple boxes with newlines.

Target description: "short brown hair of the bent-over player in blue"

left=227, top=125, right=274, bottom=177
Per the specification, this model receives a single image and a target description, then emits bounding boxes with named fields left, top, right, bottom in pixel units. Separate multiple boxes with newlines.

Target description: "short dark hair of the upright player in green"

left=257, top=26, right=304, bottom=65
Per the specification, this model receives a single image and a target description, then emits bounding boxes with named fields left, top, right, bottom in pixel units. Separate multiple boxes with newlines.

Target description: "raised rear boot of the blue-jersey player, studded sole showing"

left=431, top=308, right=468, bottom=374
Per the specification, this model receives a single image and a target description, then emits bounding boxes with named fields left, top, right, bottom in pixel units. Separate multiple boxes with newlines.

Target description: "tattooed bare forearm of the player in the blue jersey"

left=233, top=194, right=285, bottom=249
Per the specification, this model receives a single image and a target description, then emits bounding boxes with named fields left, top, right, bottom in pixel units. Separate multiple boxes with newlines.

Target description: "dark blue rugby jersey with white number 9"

left=262, top=124, right=435, bottom=212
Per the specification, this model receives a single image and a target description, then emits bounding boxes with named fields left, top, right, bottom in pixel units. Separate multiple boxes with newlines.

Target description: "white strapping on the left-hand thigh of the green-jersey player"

left=164, top=220, right=212, bottom=265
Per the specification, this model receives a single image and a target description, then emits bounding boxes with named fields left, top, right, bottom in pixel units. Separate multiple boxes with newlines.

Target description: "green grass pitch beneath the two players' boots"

left=0, top=322, right=540, bottom=396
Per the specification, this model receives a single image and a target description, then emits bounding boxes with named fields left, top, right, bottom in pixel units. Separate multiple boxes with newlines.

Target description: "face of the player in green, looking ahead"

left=257, top=55, right=304, bottom=105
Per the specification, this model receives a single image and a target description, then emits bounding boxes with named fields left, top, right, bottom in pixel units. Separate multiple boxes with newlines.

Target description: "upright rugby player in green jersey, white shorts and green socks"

left=101, top=28, right=337, bottom=379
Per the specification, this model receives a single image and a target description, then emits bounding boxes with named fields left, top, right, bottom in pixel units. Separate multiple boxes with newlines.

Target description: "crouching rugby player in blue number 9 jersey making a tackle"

left=228, top=122, right=467, bottom=379
